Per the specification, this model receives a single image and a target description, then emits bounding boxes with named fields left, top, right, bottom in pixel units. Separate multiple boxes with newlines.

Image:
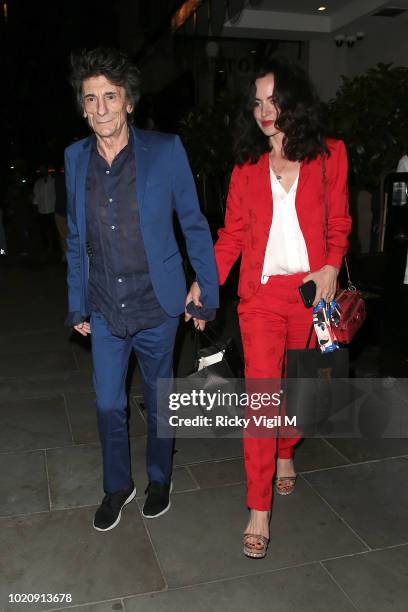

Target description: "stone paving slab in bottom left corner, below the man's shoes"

left=0, top=504, right=165, bottom=612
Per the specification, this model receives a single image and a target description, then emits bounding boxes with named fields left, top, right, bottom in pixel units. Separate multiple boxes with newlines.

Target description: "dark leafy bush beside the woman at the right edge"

left=326, top=63, right=408, bottom=191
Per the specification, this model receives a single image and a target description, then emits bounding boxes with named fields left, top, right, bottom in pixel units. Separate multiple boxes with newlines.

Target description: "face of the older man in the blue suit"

left=82, top=76, right=133, bottom=138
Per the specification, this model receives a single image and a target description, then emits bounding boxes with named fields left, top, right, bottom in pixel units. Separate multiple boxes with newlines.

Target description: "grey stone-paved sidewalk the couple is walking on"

left=0, top=266, right=408, bottom=612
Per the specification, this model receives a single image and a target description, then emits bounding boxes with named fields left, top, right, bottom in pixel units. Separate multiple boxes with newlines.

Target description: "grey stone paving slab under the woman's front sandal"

left=139, top=480, right=364, bottom=587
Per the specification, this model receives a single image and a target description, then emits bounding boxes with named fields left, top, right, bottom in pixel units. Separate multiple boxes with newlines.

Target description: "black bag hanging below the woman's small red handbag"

left=283, top=326, right=351, bottom=437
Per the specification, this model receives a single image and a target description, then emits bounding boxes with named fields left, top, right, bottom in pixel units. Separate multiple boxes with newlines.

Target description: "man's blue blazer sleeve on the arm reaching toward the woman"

left=171, top=136, right=219, bottom=309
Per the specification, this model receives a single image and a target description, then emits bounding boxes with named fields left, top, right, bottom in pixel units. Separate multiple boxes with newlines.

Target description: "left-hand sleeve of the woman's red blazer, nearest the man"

left=214, top=166, right=243, bottom=285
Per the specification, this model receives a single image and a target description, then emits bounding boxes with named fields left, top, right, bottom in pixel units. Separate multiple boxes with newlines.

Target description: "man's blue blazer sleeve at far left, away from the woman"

left=65, top=151, right=84, bottom=327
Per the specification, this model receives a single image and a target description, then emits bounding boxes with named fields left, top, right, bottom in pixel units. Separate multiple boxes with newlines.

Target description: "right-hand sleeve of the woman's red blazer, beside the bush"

left=326, top=140, right=351, bottom=270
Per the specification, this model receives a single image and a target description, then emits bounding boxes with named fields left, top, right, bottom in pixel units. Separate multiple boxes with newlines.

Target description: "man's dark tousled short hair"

left=70, top=47, right=140, bottom=112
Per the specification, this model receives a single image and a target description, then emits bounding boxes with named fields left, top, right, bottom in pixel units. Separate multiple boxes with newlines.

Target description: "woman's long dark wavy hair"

left=234, top=59, right=328, bottom=165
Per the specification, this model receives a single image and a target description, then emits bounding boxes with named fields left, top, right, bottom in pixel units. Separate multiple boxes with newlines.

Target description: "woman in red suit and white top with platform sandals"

left=215, top=60, right=351, bottom=558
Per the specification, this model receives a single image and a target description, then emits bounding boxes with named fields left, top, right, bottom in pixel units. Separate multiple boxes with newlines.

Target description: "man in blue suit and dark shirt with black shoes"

left=65, top=48, right=218, bottom=531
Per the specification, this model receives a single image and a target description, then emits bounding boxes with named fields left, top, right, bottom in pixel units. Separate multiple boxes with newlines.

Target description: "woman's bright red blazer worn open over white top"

left=215, top=139, right=351, bottom=299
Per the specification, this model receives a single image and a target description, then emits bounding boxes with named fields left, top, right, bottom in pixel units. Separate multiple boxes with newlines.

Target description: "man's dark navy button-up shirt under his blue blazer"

left=86, top=130, right=166, bottom=338
